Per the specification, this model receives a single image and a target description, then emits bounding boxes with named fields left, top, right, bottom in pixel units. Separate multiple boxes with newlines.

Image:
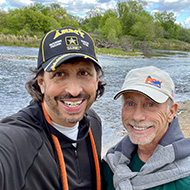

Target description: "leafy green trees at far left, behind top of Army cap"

left=0, top=3, right=79, bottom=38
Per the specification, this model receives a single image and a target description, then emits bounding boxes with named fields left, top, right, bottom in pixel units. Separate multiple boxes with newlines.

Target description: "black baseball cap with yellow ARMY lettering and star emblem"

left=37, top=27, right=101, bottom=72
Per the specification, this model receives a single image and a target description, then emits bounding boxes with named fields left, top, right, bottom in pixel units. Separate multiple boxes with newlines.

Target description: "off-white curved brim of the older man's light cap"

left=114, top=86, right=169, bottom=103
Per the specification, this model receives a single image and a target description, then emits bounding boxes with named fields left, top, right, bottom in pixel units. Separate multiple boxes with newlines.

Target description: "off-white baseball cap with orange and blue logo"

left=114, top=66, right=175, bottom=103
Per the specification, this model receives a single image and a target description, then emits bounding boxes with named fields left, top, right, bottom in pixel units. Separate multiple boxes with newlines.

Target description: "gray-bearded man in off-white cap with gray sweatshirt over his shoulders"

left=102, top=66, right=190, bottom=190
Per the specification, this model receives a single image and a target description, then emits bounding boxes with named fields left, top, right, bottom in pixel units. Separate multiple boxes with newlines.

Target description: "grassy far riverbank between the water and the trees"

left=0, top=33, right=190, bottom=58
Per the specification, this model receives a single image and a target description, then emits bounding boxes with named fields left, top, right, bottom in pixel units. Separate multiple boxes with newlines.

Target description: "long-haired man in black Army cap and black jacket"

left=0, top=27, right=105, bottom=190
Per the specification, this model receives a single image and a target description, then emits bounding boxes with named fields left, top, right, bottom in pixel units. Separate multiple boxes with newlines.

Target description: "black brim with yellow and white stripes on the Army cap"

left=42, top=53, right=101, bottom=72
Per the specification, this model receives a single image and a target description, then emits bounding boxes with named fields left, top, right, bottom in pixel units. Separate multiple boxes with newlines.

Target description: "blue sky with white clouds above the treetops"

left=0, top=0, right=190, bottom=29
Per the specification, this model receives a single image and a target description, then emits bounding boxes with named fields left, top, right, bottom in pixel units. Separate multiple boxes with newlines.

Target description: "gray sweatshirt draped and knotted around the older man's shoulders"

left=103, top=117, right=190, bottom=190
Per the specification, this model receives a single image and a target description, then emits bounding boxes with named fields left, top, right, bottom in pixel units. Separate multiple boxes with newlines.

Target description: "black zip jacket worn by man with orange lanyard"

left=0, top=102, right=102, bottom=190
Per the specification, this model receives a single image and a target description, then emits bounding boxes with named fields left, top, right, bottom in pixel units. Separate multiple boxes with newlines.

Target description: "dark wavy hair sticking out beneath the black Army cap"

left=25, top=60, right=106, bottom=102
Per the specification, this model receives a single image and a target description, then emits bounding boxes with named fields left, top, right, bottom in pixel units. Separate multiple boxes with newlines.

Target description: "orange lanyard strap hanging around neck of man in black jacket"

left=42, top=102, right=101, bottom=190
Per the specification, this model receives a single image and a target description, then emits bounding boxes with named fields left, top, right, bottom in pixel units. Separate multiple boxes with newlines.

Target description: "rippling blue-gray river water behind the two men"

left=0, top=46, right=190, bottom=153
